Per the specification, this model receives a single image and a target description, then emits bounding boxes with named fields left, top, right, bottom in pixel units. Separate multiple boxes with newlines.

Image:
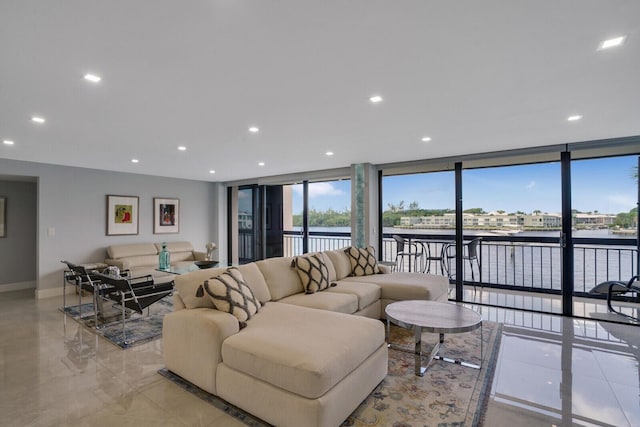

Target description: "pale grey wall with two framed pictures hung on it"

left=0, top=159, right=221, bottom=297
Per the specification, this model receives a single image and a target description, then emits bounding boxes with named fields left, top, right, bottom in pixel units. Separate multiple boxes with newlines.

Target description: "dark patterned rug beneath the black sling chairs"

left=60, top=296, right=173, bottom=348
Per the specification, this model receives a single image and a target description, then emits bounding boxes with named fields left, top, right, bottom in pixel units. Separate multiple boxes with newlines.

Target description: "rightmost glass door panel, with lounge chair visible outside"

left=571, top=155, right=639, bottom=321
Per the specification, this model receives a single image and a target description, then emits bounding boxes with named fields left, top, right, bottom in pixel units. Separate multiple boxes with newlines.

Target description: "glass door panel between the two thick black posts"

left=461, top=162, right=563, bottom=313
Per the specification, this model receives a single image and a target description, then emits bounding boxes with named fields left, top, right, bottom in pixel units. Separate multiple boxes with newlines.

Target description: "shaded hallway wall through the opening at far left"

left=0, top=177, right=37, bottom=292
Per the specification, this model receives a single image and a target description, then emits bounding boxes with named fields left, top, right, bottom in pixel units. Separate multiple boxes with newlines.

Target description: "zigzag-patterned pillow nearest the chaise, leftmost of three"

left=204, top=267, right=260, bottom=328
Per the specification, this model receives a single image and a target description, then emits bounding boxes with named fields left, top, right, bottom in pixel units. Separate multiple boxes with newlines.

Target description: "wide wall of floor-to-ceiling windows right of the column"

left=380, top=141, right=640, bottom=321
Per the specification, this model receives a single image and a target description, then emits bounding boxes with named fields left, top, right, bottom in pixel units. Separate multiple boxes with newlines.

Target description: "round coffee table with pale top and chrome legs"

left=385, top=300, right=483, bottom=377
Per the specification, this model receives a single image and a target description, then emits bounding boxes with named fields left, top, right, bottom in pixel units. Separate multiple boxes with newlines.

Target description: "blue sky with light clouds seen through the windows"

left=293, top=156, right=638, bottom=214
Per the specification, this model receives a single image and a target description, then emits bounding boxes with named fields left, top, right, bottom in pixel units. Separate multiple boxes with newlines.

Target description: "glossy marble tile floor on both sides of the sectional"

left=0, top=291, right=640, bottom=427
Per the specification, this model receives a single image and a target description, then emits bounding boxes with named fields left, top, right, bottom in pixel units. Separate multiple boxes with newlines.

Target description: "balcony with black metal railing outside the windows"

left=284, top=232, right=639, bottom=321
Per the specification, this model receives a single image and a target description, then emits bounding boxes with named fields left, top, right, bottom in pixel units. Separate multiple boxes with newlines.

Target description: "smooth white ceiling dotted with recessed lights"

left=0, top=0, right=640, bottom=181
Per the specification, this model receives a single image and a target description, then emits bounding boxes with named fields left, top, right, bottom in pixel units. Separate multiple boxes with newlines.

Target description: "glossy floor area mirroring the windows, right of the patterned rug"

left=485, top=310, right=640, bottom=426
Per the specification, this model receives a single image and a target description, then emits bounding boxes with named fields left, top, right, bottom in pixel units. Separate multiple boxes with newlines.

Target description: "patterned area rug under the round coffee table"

left=159, top=321, right=502, bottom=427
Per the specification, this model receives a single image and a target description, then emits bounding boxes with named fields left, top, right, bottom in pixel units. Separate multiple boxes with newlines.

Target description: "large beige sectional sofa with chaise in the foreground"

left=163, top=250, right=448, bottom=427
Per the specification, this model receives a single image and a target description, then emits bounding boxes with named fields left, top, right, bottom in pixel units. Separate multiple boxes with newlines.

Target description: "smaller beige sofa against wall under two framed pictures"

left=104, top=242, right=205, bottom=282
